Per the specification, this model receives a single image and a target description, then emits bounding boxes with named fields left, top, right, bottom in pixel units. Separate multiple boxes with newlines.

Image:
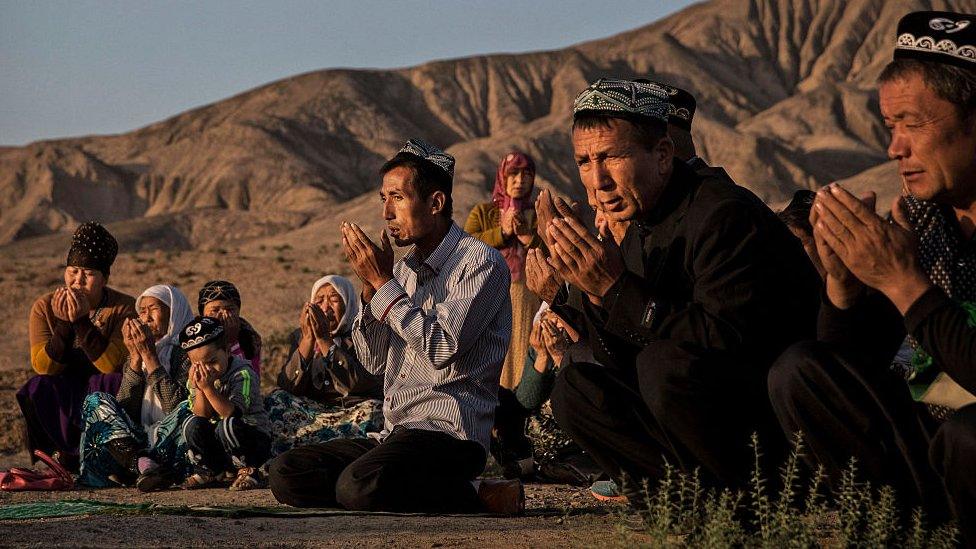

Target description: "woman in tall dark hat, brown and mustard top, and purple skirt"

left=17, top=223, right=135, bottom=471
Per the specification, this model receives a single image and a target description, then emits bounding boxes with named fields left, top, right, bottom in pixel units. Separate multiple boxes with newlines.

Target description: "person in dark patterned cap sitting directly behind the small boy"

left=197, top=280, right=261, bottom=377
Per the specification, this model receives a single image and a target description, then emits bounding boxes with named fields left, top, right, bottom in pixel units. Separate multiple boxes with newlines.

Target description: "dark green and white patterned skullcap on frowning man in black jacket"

left=573, top=78, right=668, bottom=122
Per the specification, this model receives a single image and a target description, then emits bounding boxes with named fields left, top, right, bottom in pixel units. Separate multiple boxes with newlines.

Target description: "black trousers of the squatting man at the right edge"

left=769, top=342, right=976, bottom=546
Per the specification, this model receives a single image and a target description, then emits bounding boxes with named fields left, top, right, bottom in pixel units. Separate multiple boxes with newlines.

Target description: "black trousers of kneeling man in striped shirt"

left=269, top=428, right=486, bottom=513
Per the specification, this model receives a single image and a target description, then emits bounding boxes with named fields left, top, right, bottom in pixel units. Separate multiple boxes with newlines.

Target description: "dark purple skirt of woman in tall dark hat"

left=17, top=364, right=122, bottom=470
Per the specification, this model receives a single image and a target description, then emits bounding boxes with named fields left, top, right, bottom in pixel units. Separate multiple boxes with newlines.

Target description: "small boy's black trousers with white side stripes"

left=183, top=416, right=271, bottom=473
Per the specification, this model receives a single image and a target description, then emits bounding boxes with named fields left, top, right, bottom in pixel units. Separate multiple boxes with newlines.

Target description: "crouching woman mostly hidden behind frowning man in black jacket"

left=515, top=303, right=603, bottom=486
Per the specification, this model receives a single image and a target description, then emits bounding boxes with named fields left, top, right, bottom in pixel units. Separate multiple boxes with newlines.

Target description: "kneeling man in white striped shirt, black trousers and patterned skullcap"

left=271, top=140, right=524, bottom=514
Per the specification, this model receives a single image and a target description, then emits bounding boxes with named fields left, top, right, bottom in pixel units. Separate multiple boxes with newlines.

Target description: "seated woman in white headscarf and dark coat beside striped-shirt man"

left=265, top=275, right=383, bottom=456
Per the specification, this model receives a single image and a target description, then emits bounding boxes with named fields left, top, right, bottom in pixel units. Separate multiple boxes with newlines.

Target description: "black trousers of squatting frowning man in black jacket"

left=552, top=341, right=785, bottom=506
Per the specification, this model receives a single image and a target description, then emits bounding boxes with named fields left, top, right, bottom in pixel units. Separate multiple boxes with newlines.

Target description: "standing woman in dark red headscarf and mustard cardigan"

left=464, top=151, right=542, bottom=391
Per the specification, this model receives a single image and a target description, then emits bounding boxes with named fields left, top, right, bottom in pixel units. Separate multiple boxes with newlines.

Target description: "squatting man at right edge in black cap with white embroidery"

left=769, top=12, right=976, bottom=546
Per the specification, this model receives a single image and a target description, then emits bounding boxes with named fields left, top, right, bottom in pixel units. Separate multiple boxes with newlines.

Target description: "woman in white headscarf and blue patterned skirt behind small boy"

left=79, top=286, right=193, bottom=492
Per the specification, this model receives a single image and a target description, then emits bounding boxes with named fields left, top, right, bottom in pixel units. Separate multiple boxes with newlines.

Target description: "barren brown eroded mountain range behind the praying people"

left=0, top=0, right=976, bottom=250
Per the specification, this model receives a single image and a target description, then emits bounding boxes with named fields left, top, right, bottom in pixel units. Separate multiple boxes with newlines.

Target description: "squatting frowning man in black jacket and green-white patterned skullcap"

left=528, top=80, right=818, bottom=504
